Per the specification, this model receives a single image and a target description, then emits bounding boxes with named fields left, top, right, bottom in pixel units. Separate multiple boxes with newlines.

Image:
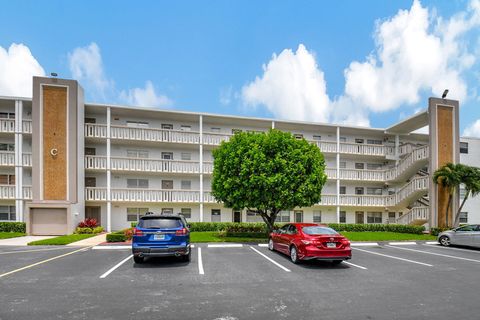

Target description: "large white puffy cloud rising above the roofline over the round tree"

left=242, top=44, right=329, bottom=122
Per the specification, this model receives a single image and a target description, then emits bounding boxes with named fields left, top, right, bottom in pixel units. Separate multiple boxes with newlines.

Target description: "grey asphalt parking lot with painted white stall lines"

left=0, top=243, right=480, bottom=320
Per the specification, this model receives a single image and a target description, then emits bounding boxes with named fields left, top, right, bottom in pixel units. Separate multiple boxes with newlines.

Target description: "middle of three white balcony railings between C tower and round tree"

left=85, top=156, right=200, bottom=174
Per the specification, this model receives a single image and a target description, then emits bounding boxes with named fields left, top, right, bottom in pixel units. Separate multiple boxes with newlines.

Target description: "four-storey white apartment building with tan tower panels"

left=0, top=77, right=474, bottom=234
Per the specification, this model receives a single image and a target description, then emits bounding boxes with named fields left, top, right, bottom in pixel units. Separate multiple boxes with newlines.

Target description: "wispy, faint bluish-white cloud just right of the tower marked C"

left=68, top=42, right=114, bottom=100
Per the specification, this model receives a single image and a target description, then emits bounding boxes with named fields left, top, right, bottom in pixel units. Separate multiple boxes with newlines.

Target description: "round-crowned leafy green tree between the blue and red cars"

left=212, top=129, right=327, bottom=231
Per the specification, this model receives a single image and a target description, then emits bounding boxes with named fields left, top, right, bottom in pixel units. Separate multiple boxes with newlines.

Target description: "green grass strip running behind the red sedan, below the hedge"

left=190, top=231, right=437, bottom=243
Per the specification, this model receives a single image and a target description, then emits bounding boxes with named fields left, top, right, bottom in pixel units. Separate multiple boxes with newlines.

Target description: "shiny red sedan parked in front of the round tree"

left=268, top=223, right=352, bottom=264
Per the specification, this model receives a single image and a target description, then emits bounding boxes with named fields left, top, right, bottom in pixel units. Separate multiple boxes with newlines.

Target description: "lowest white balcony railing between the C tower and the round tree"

left=85, top=188, right=200, bottom=203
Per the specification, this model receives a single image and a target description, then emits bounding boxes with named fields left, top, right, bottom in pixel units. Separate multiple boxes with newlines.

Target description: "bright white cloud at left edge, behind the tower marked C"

left=0, top=43, right=45, bottom=97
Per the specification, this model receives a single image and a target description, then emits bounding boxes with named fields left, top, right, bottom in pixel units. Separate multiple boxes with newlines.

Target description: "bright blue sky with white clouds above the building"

left=0, top=0, right=480, bottom=135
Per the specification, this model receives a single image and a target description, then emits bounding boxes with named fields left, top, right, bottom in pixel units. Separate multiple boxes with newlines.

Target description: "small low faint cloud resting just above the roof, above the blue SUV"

left=120, top=81, right=172, bottom=107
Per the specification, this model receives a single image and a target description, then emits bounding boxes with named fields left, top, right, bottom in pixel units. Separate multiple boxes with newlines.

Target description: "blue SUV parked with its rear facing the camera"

left=132, top=212, right=191, bottom=263
